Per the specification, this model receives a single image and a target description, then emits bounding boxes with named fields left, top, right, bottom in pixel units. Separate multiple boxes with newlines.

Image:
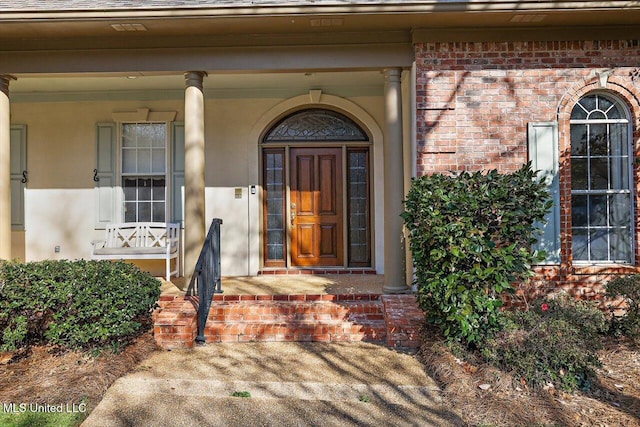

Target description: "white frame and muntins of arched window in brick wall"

left=569, top=92, right=636, bottom=265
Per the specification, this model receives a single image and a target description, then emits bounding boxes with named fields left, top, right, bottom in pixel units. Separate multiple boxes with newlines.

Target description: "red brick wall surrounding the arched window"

left=415, top=40, right=640, bottom=297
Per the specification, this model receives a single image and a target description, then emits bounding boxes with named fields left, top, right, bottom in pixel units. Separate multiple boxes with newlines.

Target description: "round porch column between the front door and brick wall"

left=382, top=68, right=409, bottom=294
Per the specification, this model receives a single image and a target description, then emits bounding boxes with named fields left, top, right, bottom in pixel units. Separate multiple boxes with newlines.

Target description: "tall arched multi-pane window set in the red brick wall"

left=570, top=93, right=633, bottom=263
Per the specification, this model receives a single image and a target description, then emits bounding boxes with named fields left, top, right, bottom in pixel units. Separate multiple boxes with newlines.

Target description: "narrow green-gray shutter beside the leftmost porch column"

left=10, top=125, right=28, bottom=230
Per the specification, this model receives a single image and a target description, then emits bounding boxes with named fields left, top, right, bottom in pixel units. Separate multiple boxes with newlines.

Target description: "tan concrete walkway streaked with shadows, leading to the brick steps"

left=82, top=343, right=463, bottom=427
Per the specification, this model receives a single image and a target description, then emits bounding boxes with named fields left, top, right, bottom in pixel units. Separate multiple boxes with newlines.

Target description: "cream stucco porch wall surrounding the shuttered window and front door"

left=11, top=90, right=384, bottom=275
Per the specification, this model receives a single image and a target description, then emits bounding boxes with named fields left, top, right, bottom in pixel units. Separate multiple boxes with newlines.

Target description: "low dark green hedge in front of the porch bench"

left=0, top=260, right=160, bottom=350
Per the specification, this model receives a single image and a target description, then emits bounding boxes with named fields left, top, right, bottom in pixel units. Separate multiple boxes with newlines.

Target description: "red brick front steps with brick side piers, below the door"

left=154, top=294, right=424, bottom=348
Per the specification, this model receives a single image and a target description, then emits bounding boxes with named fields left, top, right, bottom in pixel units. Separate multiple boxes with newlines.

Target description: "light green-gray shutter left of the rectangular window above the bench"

left=93, top=123, right=117, bottom=228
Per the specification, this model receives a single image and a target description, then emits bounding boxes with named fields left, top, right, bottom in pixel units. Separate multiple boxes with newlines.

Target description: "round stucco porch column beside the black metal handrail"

left=184, top=71, right=206, bottom=280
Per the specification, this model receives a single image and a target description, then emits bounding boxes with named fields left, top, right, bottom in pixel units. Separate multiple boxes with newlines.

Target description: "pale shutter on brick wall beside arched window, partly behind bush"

left=528, top=122, right=560, bottom=264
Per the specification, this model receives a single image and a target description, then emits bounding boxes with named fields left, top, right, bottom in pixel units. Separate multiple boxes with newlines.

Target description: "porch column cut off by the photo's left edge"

left=0, top=75, right=15, bottom=259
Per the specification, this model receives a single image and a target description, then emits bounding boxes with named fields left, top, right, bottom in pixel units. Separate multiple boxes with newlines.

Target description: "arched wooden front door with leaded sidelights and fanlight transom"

left=262, top=108, right=372, bottom=267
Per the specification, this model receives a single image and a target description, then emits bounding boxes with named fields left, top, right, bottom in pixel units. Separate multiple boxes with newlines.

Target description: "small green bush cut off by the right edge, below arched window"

left=605, top=274, right=640, bottom=341
